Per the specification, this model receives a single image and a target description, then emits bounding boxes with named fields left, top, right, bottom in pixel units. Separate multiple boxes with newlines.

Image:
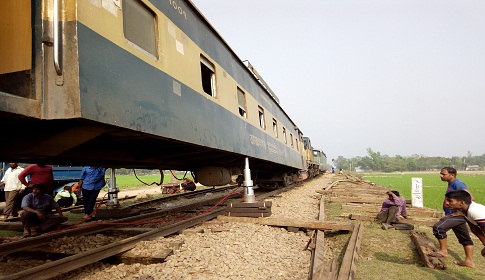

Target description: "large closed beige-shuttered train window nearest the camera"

left=123, top=0, right=158, bottom=58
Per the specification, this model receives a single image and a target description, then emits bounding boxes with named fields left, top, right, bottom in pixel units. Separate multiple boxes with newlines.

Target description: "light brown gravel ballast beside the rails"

left=51, top=176, right=330, bottom=280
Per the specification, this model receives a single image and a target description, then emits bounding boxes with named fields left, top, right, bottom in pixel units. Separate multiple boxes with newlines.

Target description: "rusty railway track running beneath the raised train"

left=0, top=186, right=290, bottom=279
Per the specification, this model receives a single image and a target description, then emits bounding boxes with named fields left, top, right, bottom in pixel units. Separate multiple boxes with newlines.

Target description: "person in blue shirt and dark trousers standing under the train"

left=79, top=166, right=106, bottom=220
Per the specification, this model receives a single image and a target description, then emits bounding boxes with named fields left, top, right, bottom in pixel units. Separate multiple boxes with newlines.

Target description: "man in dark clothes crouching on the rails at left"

left=20, top=184, right=67, bottom=237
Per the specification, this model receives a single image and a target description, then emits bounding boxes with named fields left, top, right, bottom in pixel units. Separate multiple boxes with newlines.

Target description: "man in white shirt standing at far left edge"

left=0, top=162, right=25, bottom=220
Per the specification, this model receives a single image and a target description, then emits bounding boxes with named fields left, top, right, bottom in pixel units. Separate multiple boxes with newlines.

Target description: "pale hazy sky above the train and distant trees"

left=192, top=0, right=485, bottom=158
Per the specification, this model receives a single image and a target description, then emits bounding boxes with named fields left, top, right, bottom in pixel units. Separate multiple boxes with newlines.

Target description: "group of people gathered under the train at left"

left=0, top=162, right=106, bottom=237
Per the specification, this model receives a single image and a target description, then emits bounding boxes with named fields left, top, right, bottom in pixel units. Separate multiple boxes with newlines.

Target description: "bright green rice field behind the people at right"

left=362, top=172, right=485, bottom=210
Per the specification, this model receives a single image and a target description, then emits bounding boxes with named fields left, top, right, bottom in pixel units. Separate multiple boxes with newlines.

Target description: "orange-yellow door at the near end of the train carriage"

left=0, top=0, right=36, bottom=98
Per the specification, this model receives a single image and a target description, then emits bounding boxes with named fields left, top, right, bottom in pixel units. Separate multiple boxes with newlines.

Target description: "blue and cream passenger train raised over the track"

left=0, top=0, right=326, bottom=187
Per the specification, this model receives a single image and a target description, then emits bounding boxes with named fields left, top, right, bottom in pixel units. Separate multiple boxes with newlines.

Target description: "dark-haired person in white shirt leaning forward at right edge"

left=445, top=190, right=485, bottom=257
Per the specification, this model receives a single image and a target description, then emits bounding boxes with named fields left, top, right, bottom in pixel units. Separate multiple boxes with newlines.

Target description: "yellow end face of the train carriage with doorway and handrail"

left=0, top=0, right=74, bottom=119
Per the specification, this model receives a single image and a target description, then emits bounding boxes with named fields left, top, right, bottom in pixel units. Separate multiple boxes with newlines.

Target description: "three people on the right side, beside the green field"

left=376, top=167, right=485, bottom=268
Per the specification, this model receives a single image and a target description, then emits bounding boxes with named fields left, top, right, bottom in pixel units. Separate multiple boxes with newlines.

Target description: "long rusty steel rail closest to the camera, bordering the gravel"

left=0, top=209, right=225, bottom=280
